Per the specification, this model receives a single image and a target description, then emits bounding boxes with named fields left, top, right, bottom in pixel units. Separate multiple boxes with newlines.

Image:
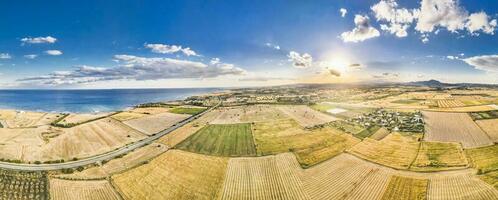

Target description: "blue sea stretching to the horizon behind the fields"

left=0, top=88, right=222, bottom=113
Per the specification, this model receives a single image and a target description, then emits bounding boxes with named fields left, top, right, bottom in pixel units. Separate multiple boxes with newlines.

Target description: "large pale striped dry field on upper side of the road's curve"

left=39, top=118, right=145, bottom=160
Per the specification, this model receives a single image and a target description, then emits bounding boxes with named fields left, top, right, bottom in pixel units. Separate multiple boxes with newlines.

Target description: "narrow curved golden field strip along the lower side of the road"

left=56, top=143, right=168, bottom=180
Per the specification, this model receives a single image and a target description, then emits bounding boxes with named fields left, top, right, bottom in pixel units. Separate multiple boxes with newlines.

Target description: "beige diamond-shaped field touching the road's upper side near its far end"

left=123, top=113, right=190, bottom=135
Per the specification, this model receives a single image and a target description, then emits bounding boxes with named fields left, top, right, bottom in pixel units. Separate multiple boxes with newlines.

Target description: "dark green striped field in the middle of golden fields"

left=176, top=124, right=256, bottom=157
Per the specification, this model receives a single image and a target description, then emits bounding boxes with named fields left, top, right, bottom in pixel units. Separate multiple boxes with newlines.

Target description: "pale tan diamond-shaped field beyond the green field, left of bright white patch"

left=277, top=105, right=338, bottom=127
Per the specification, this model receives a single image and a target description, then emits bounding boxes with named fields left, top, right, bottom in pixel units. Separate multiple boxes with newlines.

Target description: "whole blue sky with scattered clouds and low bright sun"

left=0, top=0, right=498, bottom=88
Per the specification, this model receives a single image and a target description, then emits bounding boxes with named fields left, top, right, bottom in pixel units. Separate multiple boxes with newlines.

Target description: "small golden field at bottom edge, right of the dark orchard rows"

left=50, top=178, right=121, bottom=200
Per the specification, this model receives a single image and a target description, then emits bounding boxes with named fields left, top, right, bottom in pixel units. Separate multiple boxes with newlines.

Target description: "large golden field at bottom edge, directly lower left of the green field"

left=112, top=150, right=228, bottom=199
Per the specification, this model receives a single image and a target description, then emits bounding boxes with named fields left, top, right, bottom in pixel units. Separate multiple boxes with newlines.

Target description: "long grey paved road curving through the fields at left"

left=0, top=104, right=220, bottom=171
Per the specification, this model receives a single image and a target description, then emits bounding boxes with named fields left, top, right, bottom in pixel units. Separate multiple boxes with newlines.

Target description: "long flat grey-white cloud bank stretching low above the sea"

left=18, top=55, right=245, bottom=85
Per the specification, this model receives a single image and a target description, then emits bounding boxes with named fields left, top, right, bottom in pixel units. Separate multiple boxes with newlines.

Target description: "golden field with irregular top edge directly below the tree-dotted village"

left=348, top=133, right=419, bottom=169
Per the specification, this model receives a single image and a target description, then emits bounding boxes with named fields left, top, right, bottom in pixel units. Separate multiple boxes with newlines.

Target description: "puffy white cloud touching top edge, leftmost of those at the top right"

left=370, top=0, right=418, bottom=37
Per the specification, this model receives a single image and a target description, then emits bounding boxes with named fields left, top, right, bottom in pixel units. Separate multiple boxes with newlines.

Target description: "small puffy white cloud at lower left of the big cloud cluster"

left=341, top=15, right=380, bottom=42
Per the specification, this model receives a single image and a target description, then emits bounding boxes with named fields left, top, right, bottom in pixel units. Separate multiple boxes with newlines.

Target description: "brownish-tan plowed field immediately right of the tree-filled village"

left=423, top=112, right=493, bottom=148
